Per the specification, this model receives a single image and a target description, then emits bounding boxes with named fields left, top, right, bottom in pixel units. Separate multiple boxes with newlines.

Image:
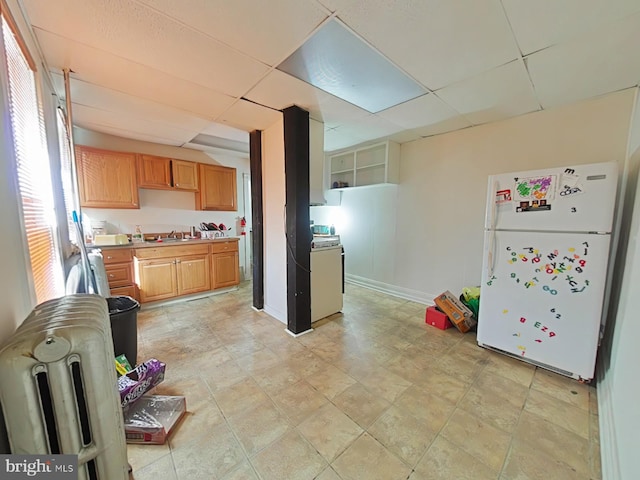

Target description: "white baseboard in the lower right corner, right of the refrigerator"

left=597, top=352, right=621, bottom=480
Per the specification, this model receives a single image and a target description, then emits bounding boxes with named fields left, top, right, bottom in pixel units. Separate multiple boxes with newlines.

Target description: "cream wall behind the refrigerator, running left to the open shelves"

left=341, top=89, right=633, bottom=303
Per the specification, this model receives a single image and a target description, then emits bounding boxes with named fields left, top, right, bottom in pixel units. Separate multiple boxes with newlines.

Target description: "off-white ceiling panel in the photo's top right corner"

left=502, top=0, right=640, bottom=55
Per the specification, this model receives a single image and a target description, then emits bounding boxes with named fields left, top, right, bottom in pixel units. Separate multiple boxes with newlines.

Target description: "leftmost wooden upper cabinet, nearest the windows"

left=75, top=145, right=140, bottom=208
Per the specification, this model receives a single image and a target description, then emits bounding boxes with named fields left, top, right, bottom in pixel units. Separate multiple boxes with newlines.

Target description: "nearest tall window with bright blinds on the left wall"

left=2, top=12, right=64, bottom=303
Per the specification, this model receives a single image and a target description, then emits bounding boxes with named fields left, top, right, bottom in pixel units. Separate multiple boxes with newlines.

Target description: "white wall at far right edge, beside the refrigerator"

left=598, top=89, right=640, bottom=480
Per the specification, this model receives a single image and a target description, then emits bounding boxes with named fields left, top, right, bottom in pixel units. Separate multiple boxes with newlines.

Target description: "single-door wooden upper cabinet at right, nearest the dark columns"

left=196, top=163, right=238, bottom=211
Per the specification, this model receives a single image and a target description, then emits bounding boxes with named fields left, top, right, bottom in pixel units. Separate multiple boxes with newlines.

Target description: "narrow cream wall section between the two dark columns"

left=262, top=120, right=287, bottom=325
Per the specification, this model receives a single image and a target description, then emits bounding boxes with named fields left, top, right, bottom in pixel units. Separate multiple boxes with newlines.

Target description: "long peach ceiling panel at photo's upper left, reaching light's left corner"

left=25, top=0, right=268, bottom=96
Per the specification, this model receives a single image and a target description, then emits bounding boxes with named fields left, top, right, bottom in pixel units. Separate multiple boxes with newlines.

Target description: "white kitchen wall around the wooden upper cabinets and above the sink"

left=73, top=127, right=249, bottom=276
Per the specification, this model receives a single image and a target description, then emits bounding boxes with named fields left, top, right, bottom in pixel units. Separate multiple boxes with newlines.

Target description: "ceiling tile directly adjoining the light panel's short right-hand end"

left=378, top=93, right=460, bottom=129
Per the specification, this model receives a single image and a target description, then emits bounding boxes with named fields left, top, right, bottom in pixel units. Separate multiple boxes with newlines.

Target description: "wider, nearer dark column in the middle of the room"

left=283, top=105, right=311, bottom=334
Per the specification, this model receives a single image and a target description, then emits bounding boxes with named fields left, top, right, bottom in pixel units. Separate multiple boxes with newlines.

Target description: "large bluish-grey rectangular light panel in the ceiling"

left=277, top=20, right=426, bottom=113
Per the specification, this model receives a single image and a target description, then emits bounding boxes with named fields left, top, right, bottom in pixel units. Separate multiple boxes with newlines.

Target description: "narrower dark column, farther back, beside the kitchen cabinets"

left=249, top=130, right=264, bottom=310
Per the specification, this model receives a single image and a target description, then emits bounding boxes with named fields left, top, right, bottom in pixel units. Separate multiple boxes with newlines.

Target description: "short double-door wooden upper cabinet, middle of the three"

left=138, top=155, right=198, bottom=192
